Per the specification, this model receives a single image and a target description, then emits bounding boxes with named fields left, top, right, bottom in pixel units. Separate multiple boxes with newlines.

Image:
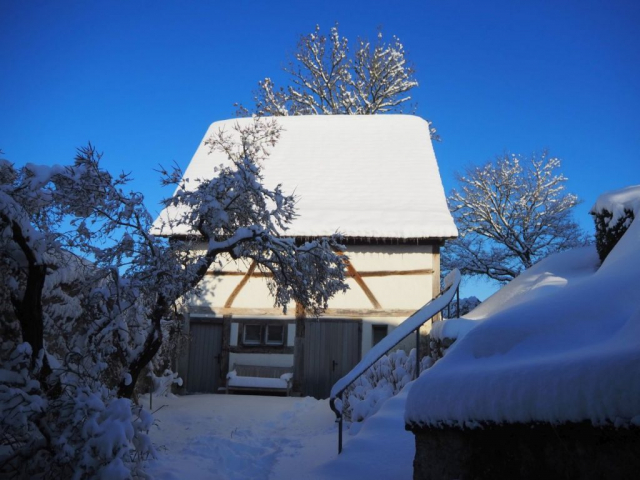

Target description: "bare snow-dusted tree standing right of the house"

left=443, top=151, right=585, bottom=282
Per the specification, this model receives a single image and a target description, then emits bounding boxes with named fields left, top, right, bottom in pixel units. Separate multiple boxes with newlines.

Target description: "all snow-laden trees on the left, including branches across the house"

left=0, top=119, right=346, bottom=478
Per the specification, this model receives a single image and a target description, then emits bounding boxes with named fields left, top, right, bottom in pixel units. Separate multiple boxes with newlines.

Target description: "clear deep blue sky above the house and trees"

left=0, top=0, right=640, bottom=297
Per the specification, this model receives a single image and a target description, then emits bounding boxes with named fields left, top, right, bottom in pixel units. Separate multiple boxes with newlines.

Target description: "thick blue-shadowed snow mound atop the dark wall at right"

left=405, top=187, right=640, bottom=426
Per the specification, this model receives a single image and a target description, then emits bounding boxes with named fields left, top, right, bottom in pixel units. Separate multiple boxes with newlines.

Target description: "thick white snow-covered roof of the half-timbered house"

left=154, top=115, right=458, bottom=239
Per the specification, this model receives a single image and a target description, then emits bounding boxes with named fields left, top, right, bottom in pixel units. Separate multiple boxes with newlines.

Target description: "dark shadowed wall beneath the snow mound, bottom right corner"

left=413, top=422, right=640, bottom=480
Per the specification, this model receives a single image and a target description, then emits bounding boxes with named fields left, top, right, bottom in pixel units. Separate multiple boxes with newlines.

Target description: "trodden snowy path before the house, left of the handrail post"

left=150, top=395, right=336, bottom=480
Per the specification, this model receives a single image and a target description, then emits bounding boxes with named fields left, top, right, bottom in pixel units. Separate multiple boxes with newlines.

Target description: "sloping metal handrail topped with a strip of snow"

left=329, top=270, right=460, bottom=454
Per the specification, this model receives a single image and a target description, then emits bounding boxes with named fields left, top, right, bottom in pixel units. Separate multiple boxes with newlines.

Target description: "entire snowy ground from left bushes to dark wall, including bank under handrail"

left=142, top=384, right=415, bottom=480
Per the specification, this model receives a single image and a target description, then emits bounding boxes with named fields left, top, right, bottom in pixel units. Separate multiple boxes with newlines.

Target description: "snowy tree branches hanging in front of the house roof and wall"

left=155, top=119, right=346, bottom=315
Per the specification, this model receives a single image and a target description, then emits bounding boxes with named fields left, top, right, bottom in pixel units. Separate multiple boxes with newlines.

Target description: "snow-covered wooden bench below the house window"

left=227, top=363, right=293, bottom=396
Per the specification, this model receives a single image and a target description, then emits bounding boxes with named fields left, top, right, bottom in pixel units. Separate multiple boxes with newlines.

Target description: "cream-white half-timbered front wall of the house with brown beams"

left=181, top=245, right=439, bottom=392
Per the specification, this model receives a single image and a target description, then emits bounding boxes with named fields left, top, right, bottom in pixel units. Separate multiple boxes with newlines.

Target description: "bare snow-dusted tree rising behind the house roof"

left=237, top=25, right=438, bottom=139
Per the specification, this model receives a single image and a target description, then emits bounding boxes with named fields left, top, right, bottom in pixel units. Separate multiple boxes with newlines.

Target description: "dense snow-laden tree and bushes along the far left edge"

left=0, top=146, right=154, bottom=478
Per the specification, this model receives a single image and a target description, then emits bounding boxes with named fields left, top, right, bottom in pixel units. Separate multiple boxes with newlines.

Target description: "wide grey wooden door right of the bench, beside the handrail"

left=302, top=319, right=362, bottom=398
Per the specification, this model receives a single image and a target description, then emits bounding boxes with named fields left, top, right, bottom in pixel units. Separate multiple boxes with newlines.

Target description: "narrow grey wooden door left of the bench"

left=187, top=320, right=222, bottom=393
